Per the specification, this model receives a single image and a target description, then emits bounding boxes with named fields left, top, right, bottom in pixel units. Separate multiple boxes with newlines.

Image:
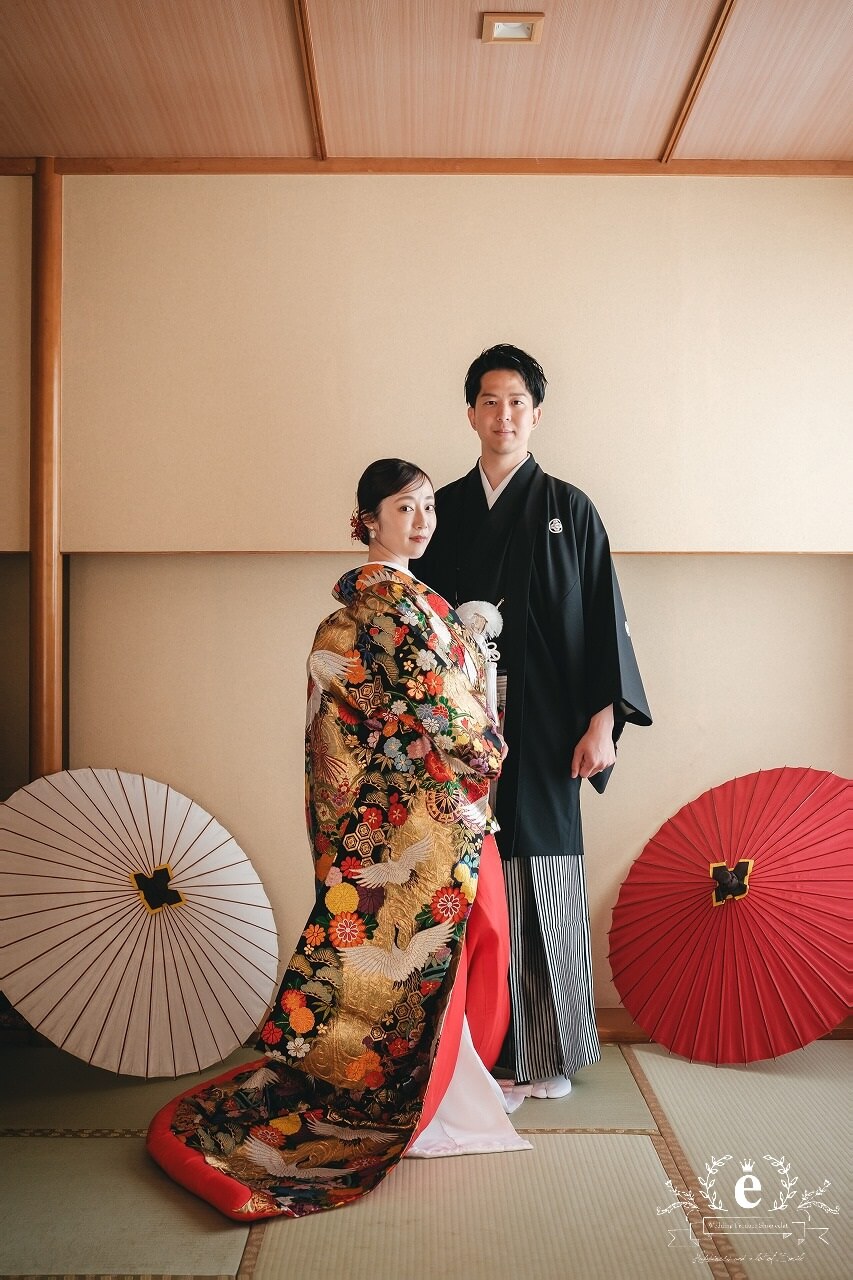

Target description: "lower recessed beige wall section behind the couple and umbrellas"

left=70, top=556, right=853, bottom=1005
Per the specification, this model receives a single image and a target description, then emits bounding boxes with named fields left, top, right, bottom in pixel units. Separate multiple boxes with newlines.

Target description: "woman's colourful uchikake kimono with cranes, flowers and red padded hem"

left=149, top=564, right=508, bottom=1221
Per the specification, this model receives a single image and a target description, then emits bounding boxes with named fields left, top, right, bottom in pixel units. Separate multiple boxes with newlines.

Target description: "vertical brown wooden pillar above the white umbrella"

left=29, top=159, right=64, bottom=778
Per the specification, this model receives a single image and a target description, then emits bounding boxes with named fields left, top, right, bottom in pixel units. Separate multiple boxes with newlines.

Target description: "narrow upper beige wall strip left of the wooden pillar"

left=0, top=178, right=32, bottom=552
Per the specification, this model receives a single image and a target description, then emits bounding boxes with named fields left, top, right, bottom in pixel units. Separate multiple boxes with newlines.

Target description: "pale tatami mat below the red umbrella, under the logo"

left=625, top=1041, right=853, bottom=1280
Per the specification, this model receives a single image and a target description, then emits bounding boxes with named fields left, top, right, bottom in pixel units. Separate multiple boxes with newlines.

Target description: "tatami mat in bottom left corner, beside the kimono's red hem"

left=0, top=1138, right=248, bottom=1276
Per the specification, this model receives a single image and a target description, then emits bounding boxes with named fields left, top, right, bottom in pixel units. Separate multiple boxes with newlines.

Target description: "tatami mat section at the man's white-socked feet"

left=512, top=1044, right=654, bottom=1133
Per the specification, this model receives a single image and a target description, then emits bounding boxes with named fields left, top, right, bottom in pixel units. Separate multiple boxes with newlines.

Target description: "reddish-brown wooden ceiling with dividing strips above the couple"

left=0, top=0, right=853, bottom=173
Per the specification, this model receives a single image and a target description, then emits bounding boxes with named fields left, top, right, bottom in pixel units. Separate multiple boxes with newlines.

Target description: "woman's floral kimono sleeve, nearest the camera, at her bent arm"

left=326, top=583, right=505, bottom=778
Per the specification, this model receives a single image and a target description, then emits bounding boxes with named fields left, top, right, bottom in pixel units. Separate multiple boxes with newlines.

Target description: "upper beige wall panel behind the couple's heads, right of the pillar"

left=63, top=175, right=853, bottom=552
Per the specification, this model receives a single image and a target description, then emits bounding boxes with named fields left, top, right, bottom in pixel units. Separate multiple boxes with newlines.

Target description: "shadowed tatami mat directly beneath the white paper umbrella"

left=0, top=1046, right=260, bottom=1130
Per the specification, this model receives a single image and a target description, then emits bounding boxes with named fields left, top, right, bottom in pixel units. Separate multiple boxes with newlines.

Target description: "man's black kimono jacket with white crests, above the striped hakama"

left=418, top=456, right=652, bottom=859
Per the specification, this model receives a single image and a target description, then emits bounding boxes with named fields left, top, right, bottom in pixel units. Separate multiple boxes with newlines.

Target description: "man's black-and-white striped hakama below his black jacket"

left=500, top=856, right=601, bottom=1083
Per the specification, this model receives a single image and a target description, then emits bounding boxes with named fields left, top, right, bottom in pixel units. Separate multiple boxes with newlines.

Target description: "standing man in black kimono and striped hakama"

left=418, top=344, right=652, bottom=1098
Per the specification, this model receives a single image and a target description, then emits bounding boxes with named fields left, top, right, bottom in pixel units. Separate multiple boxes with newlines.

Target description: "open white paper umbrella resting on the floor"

left=0, top=769, right=278, bottom=1076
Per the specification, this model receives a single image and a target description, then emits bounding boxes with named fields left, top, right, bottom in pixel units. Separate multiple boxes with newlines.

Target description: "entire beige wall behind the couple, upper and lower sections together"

left=0, top=177, right=853, bottom=1005
